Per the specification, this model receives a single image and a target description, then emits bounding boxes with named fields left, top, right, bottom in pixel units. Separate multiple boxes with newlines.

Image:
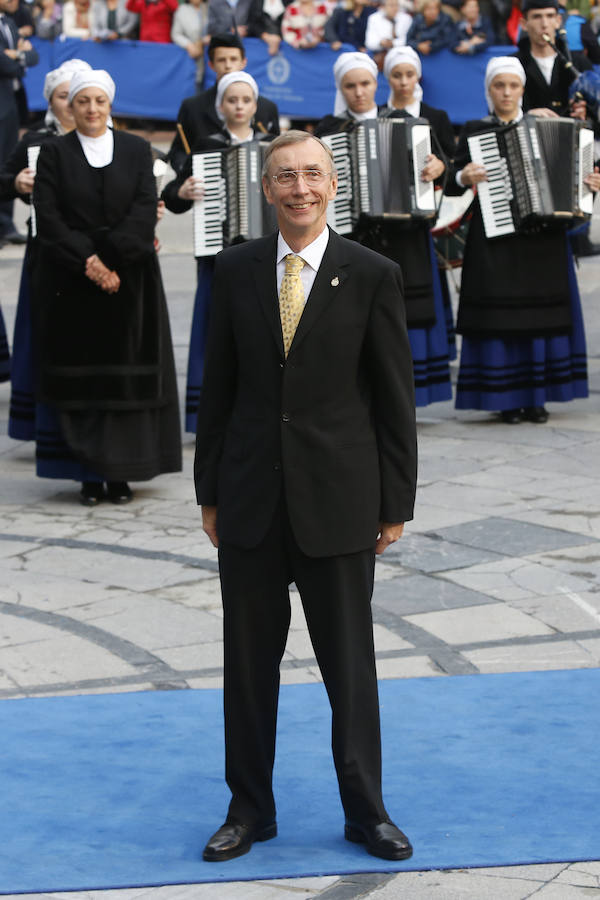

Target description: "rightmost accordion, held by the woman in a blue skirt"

left=467, top=116, right=594, bottom=238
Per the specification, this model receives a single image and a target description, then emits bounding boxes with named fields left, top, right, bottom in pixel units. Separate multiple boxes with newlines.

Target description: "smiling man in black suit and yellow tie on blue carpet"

left=195, top=131, right=416, bottom=861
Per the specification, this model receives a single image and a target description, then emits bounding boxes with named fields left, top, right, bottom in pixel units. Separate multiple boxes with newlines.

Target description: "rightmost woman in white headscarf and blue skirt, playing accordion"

left=447, top=56, right=600, bottom=425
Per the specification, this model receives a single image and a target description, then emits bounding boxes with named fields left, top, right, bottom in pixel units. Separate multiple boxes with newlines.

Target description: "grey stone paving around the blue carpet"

left=0, top=192, right=600, bottom=900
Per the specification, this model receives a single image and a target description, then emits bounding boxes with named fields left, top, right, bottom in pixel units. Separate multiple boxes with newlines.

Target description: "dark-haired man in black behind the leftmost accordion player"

left=169, top=34, right=279, bottom=174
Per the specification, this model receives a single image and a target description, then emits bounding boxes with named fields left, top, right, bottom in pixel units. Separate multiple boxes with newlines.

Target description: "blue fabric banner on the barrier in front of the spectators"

left=25, top=38, right=515, bottom=125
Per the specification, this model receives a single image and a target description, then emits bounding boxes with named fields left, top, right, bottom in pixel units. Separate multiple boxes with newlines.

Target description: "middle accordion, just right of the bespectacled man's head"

left=322, top=117, right=436, bottom=234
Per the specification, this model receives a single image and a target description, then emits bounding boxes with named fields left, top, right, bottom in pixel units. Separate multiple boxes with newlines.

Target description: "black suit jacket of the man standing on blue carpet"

left=195, top=232, right=416, bottom=557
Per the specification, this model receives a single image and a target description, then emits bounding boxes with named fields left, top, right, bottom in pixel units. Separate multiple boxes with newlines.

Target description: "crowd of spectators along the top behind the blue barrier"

left=5, top=0, right=600, bottom=82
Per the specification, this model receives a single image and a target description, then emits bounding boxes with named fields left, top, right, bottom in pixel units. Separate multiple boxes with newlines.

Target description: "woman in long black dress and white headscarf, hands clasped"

left=32, top=70, right=181, bottom=506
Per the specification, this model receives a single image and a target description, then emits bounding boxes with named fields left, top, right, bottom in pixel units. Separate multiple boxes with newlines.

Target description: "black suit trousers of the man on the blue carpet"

left=219, top=502, right=387, bottom=824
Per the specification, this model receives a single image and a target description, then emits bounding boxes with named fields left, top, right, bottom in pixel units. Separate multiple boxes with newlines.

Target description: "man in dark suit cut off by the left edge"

left=0, top=0, right=39, bottom=245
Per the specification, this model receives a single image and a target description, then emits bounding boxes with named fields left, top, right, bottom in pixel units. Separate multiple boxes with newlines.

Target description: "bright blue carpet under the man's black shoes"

left=0, top=669, right=600, bottom=893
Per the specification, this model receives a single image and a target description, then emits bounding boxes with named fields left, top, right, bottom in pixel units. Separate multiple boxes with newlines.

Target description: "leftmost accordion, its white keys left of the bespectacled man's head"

left=192, top=141, right=277, bottom=256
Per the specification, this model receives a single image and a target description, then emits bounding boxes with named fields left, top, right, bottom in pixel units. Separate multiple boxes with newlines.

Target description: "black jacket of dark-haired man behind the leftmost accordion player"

left=168, top=84, right=279, bottom=172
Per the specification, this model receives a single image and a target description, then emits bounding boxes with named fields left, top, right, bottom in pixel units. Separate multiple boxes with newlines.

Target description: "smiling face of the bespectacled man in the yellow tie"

left=263, top=137, right=337, bottom=251
